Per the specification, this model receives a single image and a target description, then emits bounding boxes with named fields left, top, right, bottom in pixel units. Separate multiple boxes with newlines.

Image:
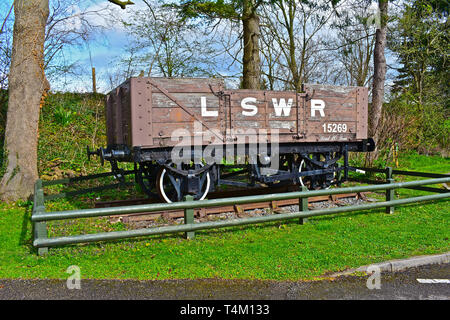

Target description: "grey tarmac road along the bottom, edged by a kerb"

left=0, top=264, right=450, bottom=300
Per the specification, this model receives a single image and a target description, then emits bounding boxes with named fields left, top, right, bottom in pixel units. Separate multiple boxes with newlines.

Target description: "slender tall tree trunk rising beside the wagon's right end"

left=369, top=0, right=388, bottom=150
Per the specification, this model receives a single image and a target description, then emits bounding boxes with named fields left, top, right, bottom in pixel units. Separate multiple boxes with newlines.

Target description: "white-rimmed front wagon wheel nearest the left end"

left=156, top=164, right=211, bottom=203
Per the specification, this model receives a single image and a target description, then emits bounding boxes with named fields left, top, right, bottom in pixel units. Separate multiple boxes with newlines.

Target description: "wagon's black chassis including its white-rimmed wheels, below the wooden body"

left=88, top=139, right=374, bottom=202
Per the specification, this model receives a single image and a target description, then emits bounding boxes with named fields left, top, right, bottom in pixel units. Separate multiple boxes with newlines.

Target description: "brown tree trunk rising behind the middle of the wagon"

left=242, top=0, right=261, bottom=89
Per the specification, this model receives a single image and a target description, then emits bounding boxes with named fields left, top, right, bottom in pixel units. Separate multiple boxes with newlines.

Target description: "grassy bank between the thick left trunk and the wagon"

left=38, top=93, right=109, bottom=180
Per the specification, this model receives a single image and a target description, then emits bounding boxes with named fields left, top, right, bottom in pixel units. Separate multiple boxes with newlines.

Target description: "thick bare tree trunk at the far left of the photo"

left=0, top=0, right=49, bottom=201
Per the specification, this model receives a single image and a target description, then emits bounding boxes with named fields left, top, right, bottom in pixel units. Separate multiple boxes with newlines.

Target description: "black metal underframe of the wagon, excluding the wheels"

left=88, top=139, right=374, bottom=200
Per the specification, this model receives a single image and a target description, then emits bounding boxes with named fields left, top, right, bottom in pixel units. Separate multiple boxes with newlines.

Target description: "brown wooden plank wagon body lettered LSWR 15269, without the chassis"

left=106, top=77, right=368, bottom=149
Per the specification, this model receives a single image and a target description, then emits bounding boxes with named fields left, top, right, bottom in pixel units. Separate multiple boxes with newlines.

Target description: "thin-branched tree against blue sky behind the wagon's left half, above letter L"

left=122, top=0, right=215, bottom=77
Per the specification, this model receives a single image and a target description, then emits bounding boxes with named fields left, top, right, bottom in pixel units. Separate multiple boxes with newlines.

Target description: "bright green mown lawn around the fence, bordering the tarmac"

left=0, top=154, right=450, bottom=280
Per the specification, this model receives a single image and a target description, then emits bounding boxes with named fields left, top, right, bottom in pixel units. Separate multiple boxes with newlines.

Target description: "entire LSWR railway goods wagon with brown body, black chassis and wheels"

left=88, top=77, right=374, bottom=202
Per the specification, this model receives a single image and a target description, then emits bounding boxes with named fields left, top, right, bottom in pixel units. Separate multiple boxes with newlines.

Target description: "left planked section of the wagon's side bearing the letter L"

left=144, top=78, right=223, bottom=147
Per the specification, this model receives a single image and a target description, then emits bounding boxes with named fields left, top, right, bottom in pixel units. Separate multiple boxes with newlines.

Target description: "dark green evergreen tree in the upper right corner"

left=388, top=0, right=449, bottom=106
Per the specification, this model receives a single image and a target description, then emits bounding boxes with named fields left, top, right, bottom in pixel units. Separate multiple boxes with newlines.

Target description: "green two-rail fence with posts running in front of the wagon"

left=31, top=168, right=450, bottom=255
